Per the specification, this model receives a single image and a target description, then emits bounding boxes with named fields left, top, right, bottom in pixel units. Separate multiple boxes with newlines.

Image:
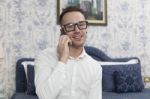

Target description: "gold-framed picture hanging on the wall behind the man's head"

left=57, top=0, right=107, bottom=25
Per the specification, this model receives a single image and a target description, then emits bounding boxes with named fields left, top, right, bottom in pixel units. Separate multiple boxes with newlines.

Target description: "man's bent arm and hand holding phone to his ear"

left=35, top=35, right=70, bottom=99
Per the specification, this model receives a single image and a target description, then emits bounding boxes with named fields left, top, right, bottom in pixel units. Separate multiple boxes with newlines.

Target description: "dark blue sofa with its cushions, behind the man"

left=11, top=46, right=150, bottom=99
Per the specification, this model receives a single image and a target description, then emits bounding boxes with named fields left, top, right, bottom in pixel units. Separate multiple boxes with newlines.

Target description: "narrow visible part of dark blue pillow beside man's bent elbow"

left=27, top=65, right=36, bottom=95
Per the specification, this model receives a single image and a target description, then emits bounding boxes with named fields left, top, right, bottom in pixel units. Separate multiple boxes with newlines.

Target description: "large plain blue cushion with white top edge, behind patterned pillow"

left=100, top=59, right=141, bottom=92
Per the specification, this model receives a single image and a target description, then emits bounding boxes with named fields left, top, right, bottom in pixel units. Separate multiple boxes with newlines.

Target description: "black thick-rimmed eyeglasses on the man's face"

left=62, top=21, right=88, bottom=32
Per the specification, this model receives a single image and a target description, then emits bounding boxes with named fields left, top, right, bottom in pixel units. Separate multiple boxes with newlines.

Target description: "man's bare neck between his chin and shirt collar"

left=70, top=46, right=83, bottom=58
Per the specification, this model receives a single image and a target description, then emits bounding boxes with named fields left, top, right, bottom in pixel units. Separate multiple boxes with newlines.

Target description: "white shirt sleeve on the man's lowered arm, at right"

left=88, top=65, right=102, bottom=99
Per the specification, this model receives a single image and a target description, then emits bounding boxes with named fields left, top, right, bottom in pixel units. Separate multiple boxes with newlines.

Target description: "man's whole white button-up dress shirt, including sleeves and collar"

left=35, top=48, right=102, bottom=99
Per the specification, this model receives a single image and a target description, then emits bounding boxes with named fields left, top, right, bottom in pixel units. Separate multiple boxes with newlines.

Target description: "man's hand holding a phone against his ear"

left=57, top=35, right=71, bottom=63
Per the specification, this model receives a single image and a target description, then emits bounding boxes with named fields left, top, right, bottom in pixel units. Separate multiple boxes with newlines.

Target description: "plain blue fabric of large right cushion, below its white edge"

left=102, top=63, right=144, bottom=91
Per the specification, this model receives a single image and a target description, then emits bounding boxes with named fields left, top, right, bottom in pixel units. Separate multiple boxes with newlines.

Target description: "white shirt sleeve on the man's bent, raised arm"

left=35, top=49, right=65, bottom=99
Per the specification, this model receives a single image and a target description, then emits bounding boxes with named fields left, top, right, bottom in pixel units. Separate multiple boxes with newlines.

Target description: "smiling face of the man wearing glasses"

left=62, top=12, right=87, bottom=47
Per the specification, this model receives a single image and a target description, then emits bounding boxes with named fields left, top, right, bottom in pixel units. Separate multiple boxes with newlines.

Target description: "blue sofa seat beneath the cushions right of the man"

left=102, top=89, right=150, bottom=99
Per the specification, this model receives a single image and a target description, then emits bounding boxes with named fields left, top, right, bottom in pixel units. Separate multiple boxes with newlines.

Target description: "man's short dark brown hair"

left=59, top=6, right=86, bottom=24
